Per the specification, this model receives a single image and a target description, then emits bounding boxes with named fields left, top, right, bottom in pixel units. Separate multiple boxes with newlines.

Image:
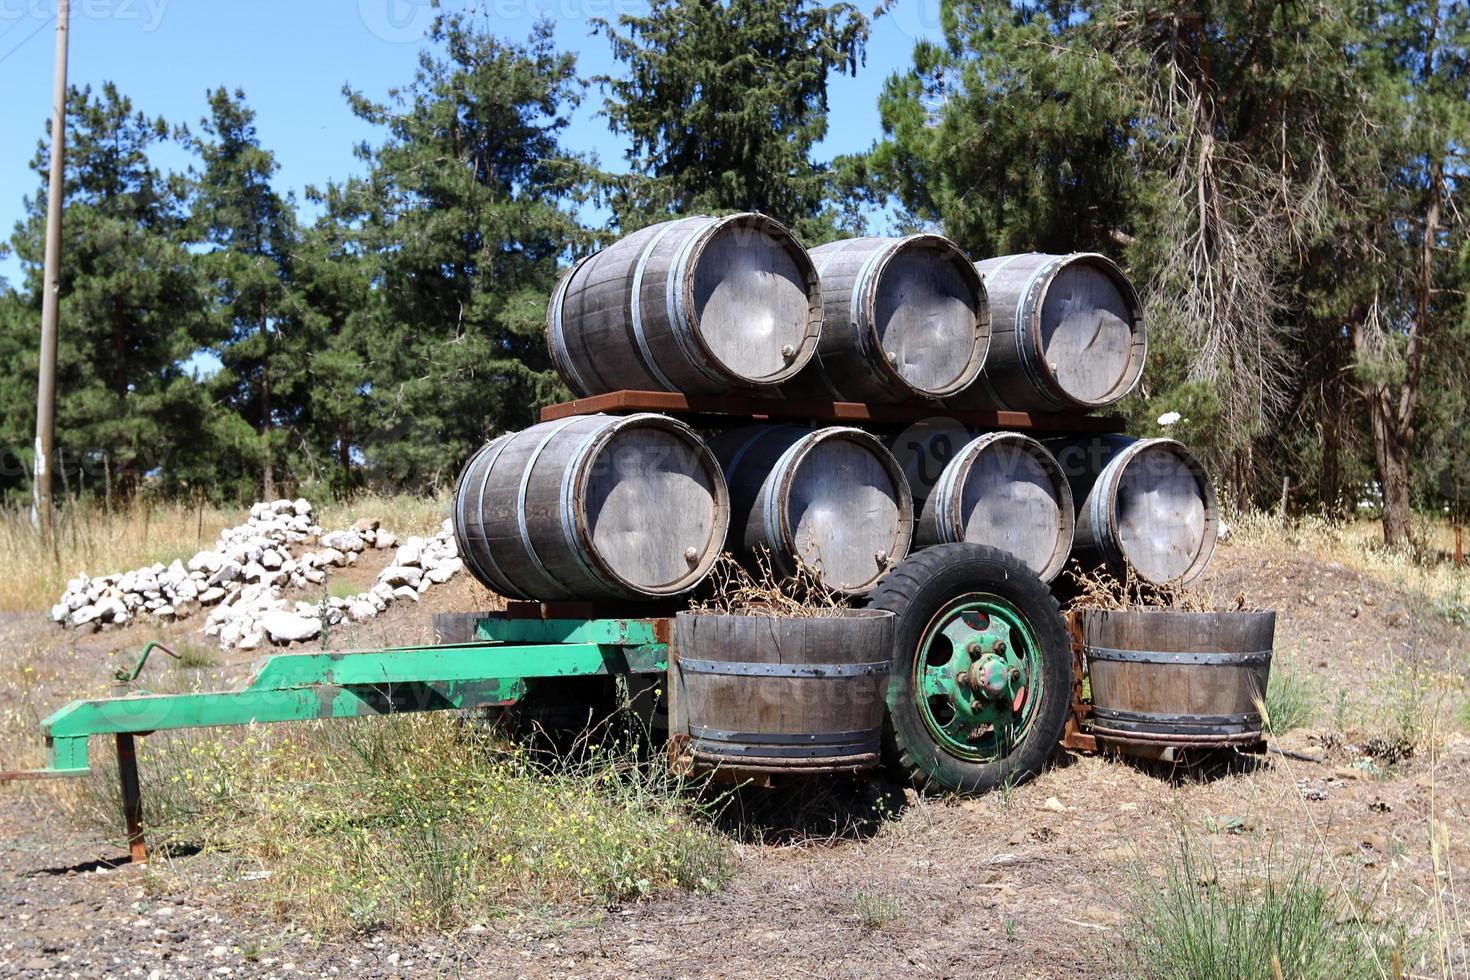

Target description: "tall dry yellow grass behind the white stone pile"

left=0, top=494, right=450, bottom=613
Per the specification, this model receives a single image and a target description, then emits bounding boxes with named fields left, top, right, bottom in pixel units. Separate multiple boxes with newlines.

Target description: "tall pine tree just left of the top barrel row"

left=328, top=15, right=591, bottom=485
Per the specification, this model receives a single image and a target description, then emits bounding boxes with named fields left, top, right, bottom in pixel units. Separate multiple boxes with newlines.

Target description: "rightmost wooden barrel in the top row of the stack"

left=953, top=253, right=1148, bottom=411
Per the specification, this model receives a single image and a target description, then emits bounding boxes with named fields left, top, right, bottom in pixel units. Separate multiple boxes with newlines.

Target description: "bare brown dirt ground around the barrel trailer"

left=0, top=545, right=1470, bottom=977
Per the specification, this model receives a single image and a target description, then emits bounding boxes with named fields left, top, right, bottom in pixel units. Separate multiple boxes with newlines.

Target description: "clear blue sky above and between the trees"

left=0, top=0, right=939, bottom=282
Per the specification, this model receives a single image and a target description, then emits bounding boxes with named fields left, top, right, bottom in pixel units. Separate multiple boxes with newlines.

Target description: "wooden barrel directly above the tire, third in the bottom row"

left=904, top=432, right=1076, bottom=582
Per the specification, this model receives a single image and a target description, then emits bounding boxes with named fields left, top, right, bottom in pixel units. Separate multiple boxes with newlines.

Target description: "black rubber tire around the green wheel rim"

left=869, top=542, right=1072, bottom=795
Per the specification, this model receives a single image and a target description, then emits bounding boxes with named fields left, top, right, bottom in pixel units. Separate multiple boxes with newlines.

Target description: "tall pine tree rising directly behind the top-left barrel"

left=595, top=0, right=867, bottom=239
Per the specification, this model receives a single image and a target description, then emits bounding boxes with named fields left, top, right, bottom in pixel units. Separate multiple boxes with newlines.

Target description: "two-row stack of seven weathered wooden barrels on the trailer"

left=454, top=213, right=1217, bottom=601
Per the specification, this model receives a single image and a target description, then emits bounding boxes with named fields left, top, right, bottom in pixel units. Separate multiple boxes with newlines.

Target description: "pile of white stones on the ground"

left=51, top=500, right=465, bottom=649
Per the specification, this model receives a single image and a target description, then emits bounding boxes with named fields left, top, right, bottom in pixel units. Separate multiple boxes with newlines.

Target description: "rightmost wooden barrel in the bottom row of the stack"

left=1051, top=436, right=1220, bottom=585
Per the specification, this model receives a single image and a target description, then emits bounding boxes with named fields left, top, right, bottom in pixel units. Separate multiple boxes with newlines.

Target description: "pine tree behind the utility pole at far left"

left=0, top=84, right=210, bottom=501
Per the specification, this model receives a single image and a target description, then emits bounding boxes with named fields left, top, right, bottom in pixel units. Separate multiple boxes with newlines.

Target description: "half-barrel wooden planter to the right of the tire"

left=1082, top=610, right=1276, bottom=746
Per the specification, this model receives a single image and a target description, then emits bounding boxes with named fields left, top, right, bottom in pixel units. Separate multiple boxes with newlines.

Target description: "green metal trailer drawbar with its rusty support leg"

left=0, top=613, right=672, bottom=861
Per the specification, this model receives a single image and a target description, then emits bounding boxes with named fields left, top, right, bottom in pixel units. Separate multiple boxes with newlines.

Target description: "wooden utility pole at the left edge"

left=31, top=0, right=72, bottom=550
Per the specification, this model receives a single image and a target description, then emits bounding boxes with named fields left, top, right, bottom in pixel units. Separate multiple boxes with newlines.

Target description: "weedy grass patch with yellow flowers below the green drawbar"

left=69, top=716, right=729, bottom=934
